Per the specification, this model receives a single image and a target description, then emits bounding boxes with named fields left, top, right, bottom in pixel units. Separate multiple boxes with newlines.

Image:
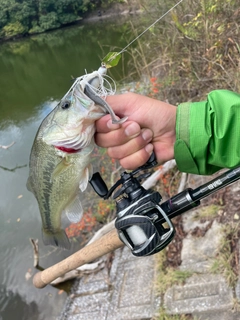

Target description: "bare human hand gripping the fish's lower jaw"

left=95, top=93, right=176, bottom=170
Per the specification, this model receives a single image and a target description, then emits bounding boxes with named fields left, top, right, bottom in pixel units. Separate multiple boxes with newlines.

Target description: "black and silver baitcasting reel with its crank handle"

left=90, top=154, right=175, bottom=256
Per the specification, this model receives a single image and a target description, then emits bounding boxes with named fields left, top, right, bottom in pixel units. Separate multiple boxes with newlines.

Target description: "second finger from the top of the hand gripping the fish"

left=95, top=120, right=142, bottom=148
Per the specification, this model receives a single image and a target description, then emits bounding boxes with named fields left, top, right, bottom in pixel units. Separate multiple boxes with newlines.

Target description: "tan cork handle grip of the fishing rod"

left=33, top=229, right=123, bottom=288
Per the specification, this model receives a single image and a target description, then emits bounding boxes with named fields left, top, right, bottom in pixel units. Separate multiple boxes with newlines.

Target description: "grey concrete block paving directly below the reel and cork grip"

left=59, top=247, right=160, bottom=320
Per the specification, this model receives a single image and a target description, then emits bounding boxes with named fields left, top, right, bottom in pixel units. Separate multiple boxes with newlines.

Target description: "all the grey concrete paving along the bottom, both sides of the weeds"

left=59, top=183, right=240, bottom=320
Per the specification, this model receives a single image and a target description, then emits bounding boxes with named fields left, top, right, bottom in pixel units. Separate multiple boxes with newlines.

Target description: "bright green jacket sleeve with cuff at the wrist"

left=174, top=90, right=240, bottom=175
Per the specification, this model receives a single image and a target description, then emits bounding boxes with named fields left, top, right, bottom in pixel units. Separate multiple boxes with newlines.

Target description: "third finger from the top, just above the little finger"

left=108, top=129, right=153, bottom=159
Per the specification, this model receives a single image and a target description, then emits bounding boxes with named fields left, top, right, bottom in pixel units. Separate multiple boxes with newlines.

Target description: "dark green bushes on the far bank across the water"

left=0, top=0, right=124, bottom=40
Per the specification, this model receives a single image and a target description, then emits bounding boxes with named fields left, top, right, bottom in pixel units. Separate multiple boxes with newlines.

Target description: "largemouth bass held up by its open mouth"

left=27, top=66, right=126, bottom=249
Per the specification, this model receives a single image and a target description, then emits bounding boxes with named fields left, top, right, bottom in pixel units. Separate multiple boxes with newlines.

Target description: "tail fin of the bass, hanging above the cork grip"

left=42, top=229, right=71, bottom=250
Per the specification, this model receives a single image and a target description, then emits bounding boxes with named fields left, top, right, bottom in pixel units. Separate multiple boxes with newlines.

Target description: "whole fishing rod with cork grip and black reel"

left=33, top=154, right=240, bottom=288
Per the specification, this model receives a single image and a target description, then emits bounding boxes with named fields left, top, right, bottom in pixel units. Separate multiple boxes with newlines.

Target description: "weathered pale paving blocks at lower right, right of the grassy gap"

left=164, top=211, right=240, bottom=320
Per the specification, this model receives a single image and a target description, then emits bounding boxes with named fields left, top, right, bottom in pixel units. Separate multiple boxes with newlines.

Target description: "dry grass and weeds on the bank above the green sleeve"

left=124, top=0, right=240, bottom=104
